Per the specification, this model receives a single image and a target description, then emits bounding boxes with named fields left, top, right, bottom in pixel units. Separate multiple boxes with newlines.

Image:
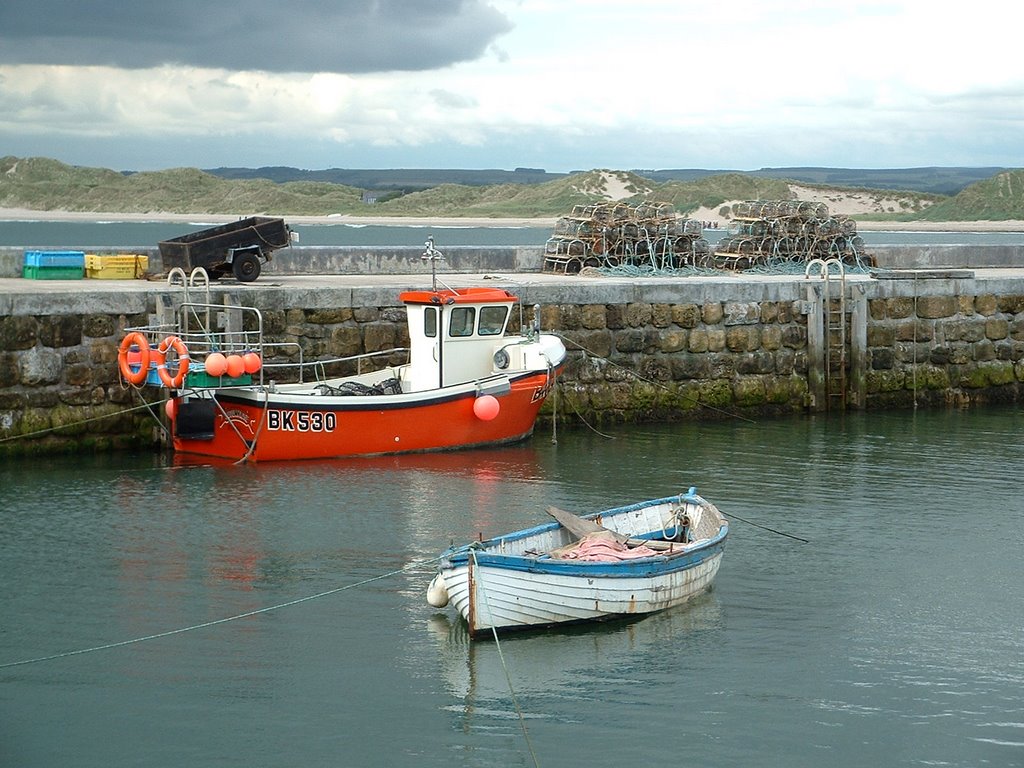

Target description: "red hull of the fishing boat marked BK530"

left=174, top=373, right=553, bottom=461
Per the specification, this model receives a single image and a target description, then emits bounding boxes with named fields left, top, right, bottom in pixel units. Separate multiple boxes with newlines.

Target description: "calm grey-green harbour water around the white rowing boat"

left=0, top=407, right=1024, bottom=768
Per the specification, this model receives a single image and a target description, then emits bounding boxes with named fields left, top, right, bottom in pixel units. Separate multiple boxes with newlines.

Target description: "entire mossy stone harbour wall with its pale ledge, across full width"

left=0, top=270, right=1024, bottom=456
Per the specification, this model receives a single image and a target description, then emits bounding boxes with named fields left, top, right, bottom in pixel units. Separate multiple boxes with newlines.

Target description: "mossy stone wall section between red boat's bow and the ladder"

left=543, top=301, right=808, bottom=423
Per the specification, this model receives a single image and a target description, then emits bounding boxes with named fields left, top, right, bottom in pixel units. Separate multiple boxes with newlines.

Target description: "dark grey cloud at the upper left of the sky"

left=0, top=0, right=511, bottom=74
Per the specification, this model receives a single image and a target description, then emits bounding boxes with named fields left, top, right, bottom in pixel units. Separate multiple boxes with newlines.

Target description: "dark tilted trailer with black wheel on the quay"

left=160, top=216, right=297, bottom=283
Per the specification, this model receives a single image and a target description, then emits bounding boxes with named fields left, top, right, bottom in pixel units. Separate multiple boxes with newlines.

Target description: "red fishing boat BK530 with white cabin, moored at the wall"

left=118, top=243, right=565, bottom=461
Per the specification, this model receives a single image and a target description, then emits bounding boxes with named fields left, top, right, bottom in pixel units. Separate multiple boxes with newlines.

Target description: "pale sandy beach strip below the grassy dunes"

left=0, top=201, right=1024, bottom=232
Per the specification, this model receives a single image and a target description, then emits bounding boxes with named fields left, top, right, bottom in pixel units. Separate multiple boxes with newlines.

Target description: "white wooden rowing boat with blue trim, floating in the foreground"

left=427, top=488, right=729, bottom=637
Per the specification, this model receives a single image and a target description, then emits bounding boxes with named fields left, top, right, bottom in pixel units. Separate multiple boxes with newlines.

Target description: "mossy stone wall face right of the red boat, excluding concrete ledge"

left=544, top=285, right=1024, bottom=423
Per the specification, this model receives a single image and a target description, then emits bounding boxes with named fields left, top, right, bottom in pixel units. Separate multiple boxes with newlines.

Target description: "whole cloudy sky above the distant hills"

left=0, top=0, right=1024, bottom=171
